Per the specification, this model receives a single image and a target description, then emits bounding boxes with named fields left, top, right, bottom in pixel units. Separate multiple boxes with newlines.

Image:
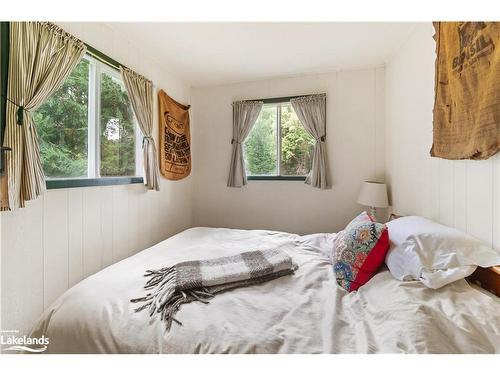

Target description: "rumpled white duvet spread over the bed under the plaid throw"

left=32, top=228, right=500, bottom=353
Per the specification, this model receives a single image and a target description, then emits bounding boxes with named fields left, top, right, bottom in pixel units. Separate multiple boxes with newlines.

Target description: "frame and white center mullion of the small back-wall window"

left=245, top=94, right=320, bottom=181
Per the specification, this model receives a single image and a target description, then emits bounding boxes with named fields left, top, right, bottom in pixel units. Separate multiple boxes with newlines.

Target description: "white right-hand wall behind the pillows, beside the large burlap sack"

left=386, top=23, right=500, bottom=248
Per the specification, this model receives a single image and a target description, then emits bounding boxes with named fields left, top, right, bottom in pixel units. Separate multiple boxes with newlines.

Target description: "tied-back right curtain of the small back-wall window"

left=290, top=94, right=330, bottom=189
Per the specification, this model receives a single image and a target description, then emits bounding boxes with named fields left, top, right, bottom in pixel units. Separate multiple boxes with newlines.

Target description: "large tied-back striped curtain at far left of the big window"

left=1, top=22, right=86, bottom=211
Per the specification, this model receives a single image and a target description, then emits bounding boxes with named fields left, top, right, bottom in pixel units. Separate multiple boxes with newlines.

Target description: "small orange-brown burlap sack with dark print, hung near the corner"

left=158, top=90, right=191, bottom=180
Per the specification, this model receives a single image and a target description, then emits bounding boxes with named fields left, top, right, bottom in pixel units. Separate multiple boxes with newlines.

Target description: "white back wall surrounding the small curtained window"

left=192, top=68, right=385, bottom=233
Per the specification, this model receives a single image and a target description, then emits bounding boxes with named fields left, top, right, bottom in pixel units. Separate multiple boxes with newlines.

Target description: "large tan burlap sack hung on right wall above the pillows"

left=431, top=22, right=500, bottom=159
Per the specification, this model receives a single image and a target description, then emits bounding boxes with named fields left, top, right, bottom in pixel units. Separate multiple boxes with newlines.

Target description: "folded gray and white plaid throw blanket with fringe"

left=131, top=249, right=297, bottom=330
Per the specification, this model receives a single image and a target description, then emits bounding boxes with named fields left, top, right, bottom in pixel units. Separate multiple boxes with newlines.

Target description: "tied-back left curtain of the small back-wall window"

left=227, top=101, right=264, bottom=187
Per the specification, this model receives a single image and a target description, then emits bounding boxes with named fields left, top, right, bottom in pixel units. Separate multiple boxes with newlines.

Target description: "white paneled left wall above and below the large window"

left=0, top=23, right=193, bottom=332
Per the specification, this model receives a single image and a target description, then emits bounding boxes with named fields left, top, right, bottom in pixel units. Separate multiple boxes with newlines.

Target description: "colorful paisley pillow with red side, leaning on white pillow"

left=332, top=212, right=389, bottom=292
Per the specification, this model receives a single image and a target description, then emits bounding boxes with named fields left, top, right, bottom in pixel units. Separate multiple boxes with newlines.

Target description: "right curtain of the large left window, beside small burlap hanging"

left=120, top=67, right=160, bottom=191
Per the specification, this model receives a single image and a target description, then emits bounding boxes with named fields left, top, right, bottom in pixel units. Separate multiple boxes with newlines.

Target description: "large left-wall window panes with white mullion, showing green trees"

left=33, top=55, right=141, bottom=180
